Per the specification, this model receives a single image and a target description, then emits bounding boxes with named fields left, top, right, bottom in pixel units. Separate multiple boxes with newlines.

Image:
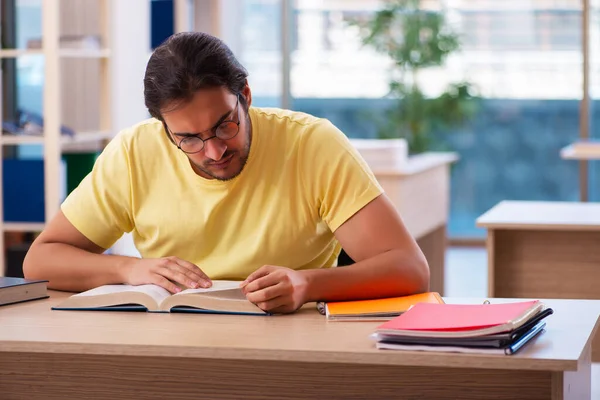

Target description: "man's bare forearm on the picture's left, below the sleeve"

left=23, top=243, right=134, bottom=292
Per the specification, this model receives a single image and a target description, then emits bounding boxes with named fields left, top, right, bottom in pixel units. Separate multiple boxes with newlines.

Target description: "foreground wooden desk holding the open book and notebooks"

left=0, top=293, right=600, bottom=400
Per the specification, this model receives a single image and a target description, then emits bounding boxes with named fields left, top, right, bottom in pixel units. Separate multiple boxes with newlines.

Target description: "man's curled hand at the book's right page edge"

left=241, top=265, right=308, bottom=314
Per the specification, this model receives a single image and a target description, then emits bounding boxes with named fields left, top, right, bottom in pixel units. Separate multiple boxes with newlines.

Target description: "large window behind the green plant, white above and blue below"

left=290, top=0, right=583, bottom=238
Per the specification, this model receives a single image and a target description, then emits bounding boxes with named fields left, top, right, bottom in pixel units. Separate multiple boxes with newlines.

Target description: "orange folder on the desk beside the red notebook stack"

left=325, top=292, right=444, bottom=321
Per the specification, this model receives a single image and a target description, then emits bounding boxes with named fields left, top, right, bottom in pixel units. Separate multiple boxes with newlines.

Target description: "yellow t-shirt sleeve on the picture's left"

left=61, top=135, right=133, bottom=249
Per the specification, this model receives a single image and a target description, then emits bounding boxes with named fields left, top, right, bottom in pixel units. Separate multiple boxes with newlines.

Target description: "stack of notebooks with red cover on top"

left=373, top=300, right=553, bottom=355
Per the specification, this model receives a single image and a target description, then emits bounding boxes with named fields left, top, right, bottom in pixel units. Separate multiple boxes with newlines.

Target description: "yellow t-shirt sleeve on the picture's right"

left=301, top=120, right=383, bottom=232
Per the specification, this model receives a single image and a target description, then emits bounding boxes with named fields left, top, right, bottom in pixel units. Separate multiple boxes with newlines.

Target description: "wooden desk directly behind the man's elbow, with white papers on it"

left=373, top=152, right=458, bottom=294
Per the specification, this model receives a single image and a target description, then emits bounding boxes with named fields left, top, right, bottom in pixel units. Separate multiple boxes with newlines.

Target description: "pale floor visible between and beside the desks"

left=444, top=247, right=600, bottom=399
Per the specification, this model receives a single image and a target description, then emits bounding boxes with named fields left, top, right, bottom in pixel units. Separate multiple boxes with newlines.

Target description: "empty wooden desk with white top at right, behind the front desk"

left=477, top=201, right=600, bottom=361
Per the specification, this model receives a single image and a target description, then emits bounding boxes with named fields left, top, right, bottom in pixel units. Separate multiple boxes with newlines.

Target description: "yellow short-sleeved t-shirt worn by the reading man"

left=61, top=107, right=382, bottom=279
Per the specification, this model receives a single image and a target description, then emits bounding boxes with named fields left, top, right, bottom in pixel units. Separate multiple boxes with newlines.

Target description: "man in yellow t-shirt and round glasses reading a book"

left=23, top=32, right=429, bottom=313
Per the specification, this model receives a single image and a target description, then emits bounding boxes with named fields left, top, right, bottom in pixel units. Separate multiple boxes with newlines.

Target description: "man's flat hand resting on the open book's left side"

left=123, top=257, right=212, bottom=293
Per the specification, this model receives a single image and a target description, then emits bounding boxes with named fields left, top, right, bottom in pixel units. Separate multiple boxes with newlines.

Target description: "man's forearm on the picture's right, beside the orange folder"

left=302, top=250, right=429, bottom=301
